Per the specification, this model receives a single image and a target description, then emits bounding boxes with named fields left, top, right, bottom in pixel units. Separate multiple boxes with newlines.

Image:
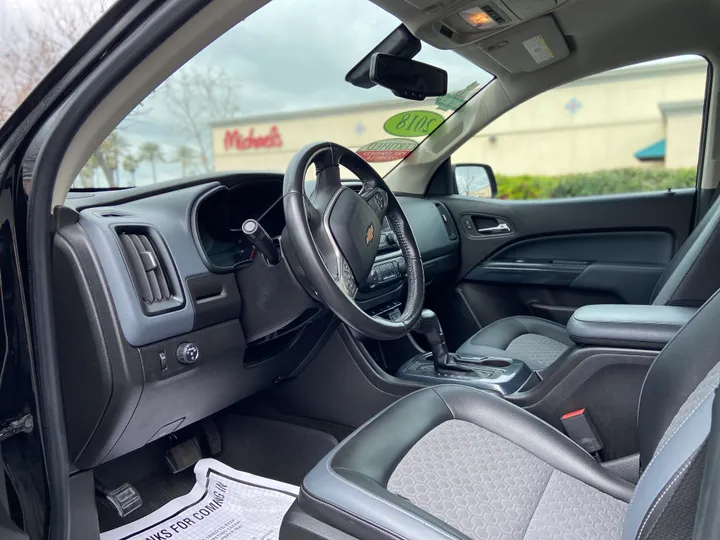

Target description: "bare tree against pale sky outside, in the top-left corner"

left=0, top=0, right=112, bottom=124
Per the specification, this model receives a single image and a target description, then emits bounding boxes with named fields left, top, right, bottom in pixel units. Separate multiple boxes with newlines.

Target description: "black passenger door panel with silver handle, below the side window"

left=441, top=189, right=695, bottom=337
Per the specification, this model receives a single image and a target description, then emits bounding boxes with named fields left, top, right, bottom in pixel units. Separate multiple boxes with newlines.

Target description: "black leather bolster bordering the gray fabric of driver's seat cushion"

left=298, top=385, right=633, bottom=540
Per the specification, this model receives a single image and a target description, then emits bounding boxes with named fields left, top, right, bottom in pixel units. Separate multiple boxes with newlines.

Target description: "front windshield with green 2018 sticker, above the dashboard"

left=73, top=0, right=491, bottom=189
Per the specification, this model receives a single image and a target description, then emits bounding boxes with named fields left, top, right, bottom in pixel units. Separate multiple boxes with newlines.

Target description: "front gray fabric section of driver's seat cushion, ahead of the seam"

left=387, top=420, right=553, bottom=540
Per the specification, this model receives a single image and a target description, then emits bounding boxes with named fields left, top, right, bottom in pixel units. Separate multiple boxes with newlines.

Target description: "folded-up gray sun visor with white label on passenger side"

left=478, top=15, right=570, bottom=73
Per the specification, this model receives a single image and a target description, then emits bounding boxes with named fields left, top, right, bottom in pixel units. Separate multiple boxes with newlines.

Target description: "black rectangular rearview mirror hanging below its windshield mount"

left=370, top=53, right=447, bottom=101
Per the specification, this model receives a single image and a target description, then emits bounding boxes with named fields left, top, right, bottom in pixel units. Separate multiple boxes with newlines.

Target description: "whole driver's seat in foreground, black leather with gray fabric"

left=280, top=288, right=720, bottom=540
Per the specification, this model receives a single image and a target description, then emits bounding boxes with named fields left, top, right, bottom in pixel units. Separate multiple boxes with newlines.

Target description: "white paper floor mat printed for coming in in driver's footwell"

left=100, top=459, right=298, bottom=540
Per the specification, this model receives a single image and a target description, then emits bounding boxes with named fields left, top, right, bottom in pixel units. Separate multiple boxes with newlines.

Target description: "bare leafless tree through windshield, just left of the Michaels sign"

left=157, top=65, right=240, bottom=172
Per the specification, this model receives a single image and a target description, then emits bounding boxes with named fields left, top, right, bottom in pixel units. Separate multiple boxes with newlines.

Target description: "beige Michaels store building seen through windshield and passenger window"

left=212, top=58, right=707, bottom=175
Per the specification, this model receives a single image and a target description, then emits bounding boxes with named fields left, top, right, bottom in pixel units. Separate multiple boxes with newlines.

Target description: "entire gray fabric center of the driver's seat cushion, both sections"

left=387, top=420, right=627, bottom=540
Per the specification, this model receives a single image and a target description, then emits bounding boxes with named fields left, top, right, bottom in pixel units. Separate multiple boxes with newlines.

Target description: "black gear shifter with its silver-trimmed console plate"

left=395, top=309, right=537, bottom=396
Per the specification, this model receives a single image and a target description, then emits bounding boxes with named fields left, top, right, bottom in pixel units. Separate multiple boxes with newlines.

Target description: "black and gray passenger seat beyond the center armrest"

left=457, top=197, right=720, bottom=371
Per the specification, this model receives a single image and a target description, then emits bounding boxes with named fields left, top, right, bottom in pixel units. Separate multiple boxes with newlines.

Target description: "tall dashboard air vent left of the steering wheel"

left=117, top=227, right=184, bottom=315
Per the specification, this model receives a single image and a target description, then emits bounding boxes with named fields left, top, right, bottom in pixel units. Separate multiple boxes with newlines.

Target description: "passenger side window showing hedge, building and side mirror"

left=452, top=56, right=707, bottom=199
